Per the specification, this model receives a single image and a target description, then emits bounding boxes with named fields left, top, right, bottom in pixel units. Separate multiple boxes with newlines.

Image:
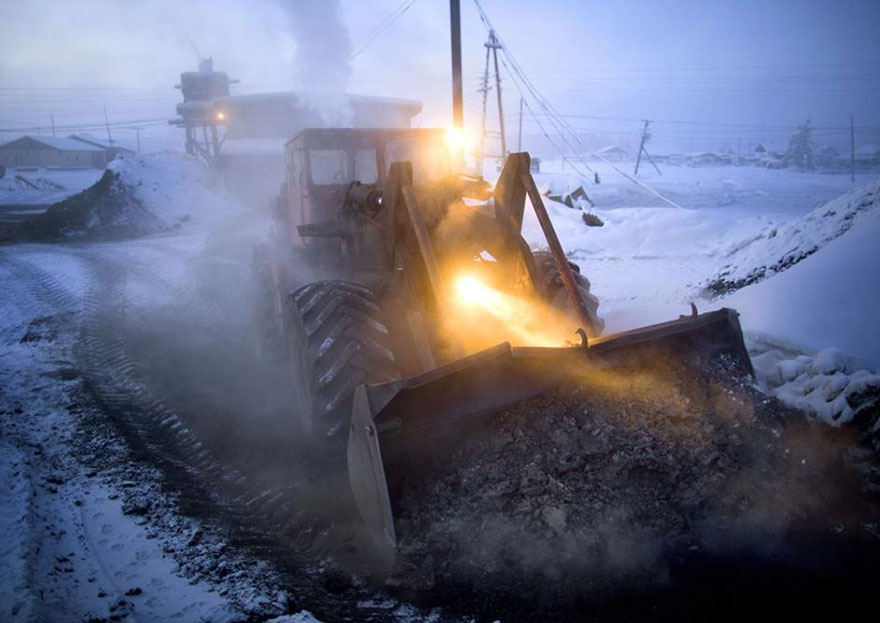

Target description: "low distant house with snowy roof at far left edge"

left=0, top=136, right=107, bottom=169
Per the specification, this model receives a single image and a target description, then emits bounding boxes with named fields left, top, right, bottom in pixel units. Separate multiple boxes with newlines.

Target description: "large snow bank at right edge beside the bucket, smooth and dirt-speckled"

left=721, top=181, right=880, bottom=426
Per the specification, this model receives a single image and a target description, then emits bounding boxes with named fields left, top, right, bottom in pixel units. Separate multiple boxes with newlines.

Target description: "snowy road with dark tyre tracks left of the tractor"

left=0, top=232, right=440, bottom=622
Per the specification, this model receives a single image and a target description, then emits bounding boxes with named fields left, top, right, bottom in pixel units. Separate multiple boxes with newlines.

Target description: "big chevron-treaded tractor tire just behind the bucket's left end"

left=286, top=281, right=399, bottom=441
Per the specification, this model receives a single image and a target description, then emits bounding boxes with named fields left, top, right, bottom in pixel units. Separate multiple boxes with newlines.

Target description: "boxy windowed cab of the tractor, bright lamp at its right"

left=277, top=128, right=453, bottom=246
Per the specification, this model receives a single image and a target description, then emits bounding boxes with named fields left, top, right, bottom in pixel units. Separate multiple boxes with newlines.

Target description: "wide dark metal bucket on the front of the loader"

left=348, top=309, right=752, bottom=565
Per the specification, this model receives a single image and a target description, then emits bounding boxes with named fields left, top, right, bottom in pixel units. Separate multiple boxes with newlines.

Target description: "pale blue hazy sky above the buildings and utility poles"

left=0, top=0, right=880, bottom=151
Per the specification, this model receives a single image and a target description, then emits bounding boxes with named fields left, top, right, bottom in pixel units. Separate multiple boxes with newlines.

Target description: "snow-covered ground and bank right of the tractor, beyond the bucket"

left=524, top=162, right=880, bottom=423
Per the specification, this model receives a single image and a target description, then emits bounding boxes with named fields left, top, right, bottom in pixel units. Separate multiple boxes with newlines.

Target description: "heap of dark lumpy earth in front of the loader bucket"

left=392, top=364, right=880, bottom=620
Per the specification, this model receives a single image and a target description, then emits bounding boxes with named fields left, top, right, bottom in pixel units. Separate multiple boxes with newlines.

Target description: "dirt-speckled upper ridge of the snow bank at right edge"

left=707, top=179, right=880, bottom=294
